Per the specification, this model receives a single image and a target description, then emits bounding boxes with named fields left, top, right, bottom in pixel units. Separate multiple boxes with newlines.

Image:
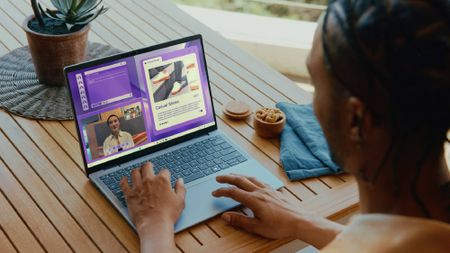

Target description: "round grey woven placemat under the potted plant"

left=0, top=42, right=121, bottom=120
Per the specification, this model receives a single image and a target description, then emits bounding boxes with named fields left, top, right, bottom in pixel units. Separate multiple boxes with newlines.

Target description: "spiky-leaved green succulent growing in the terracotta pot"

left=31, top=0, right=108, bottom=30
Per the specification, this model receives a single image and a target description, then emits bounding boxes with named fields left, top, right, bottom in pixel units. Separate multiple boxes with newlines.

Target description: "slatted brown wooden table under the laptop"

left=0, top=0, right=358, bottom=253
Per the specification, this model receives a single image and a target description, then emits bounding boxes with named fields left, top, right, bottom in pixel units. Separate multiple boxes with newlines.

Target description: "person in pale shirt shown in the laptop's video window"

left=103, top=114, right=134, bottom=156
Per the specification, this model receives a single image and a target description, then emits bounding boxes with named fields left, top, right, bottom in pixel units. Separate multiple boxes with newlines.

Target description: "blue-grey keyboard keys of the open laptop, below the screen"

left=100, top=136, right=247, bottom=206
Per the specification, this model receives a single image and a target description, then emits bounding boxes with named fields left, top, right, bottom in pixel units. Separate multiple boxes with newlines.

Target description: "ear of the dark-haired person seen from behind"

left=347, top=96, right=366, bottom=143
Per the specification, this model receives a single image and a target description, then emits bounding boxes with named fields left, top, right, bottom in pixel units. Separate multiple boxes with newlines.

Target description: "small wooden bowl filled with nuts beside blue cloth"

left=253, top=108, right=286, bottom=138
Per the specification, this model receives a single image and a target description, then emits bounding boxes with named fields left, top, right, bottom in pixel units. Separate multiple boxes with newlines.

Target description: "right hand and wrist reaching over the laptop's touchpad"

left=212, top=175, right=342, bottom=248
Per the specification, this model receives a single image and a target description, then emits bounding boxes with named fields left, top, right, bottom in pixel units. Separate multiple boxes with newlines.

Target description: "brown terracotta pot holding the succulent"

left=22, top=16, right=90, bottom=86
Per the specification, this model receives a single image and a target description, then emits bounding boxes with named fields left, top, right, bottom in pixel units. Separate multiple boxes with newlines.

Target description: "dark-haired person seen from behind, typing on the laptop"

left=121, top=0, right=450, bottom=253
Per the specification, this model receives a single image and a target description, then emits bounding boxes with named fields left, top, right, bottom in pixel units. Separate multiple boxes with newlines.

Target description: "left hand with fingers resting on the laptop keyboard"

left=120, top=163, right=186, bottom=252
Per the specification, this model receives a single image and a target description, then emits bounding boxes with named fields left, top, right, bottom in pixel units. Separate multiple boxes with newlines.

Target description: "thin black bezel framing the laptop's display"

left=64, top=34, right=217, bottom=176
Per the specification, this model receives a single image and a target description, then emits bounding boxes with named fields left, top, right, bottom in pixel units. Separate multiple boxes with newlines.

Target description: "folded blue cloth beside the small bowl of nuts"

left=276, top=102, right=342, bottom=180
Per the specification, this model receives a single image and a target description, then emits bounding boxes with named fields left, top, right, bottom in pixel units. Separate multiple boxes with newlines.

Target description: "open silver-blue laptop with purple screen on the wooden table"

left=64, top=35, right=283, bottom=232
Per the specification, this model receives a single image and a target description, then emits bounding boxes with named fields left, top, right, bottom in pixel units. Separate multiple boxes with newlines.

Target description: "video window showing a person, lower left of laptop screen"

left=81, top=102, right=148, bottom=160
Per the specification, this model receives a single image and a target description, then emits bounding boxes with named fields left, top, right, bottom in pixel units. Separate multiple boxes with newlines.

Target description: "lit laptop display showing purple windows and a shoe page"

left=66, top=37, right=215, bottom=168
